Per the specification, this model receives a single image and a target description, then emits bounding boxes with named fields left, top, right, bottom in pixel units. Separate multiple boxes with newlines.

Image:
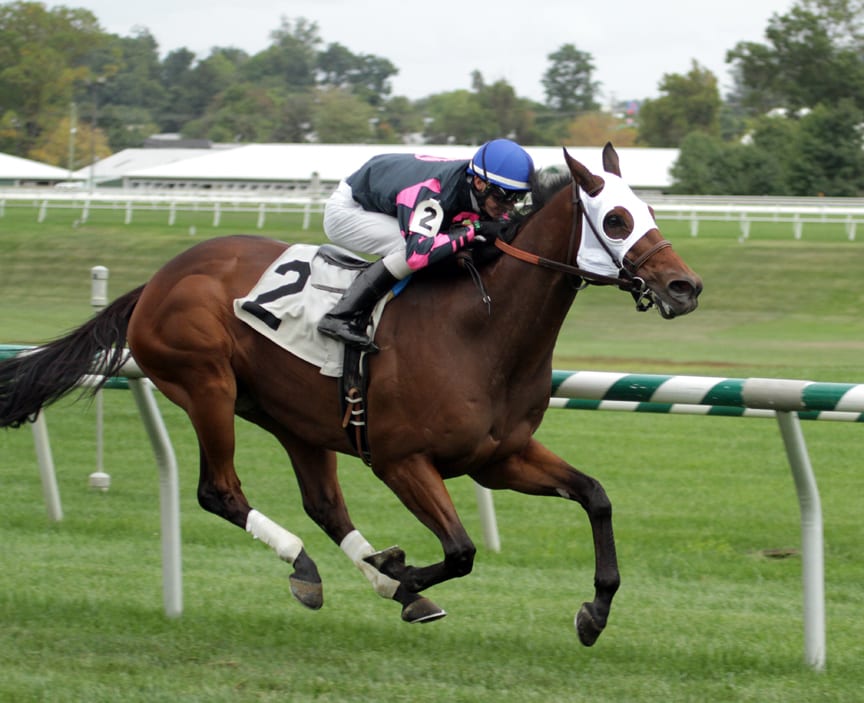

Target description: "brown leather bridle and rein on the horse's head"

left=495, top=181, right=672, bottom=311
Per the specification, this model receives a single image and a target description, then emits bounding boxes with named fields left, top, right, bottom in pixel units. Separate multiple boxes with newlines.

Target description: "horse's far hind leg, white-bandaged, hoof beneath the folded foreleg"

left=267, top=438, right=447, bottom=623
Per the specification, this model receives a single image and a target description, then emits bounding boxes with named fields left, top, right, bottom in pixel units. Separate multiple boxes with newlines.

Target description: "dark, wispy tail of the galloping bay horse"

left=0, top=285, right=144, bottom=427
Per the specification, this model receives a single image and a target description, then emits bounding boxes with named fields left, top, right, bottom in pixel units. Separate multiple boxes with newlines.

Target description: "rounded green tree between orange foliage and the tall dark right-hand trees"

left=639, top=61, right=722, bottom=147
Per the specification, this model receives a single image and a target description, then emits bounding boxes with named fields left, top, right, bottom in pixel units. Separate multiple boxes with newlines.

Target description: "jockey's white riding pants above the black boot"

left=324, top=181, right=411, bottom=280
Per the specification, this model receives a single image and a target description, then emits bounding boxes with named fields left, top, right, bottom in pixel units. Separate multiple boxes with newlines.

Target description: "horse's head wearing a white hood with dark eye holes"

left=564, top=143, right=702, bottom=319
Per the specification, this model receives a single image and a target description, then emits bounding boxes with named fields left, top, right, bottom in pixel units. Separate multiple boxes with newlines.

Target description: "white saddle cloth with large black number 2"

left=234, top=244, right=390, bottom=378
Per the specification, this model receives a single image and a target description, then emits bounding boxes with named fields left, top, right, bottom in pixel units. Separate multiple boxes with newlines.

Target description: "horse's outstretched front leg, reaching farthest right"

left=471, top=440, right=621, bottom=647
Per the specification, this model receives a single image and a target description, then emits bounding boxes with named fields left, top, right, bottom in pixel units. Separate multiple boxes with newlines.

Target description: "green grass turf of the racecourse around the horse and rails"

left=0, top=202, right=864, bottom=703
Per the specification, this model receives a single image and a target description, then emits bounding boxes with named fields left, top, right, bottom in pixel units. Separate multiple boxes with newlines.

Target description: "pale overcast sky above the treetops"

left=59, top=0, right=795, bottom=104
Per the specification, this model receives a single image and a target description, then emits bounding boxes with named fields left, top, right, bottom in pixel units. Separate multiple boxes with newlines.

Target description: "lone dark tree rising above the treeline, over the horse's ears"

left=542, top=44, right=600, bottom=114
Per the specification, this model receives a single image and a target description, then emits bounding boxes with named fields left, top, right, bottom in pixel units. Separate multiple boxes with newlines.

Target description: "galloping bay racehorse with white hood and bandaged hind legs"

left=0, top=144, right=702, bottom=646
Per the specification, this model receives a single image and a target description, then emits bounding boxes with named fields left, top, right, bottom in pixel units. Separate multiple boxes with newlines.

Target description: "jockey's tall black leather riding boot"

left=318, top=259, right=399, bottom=349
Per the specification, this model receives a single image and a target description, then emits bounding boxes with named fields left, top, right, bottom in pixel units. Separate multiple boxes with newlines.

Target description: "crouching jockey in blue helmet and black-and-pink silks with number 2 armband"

left=318, top=139, right=534, bottom=349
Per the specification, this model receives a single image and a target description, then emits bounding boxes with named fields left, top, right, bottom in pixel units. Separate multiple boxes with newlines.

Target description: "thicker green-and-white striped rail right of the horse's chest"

left=549, top=371, right=864, bottom=422
